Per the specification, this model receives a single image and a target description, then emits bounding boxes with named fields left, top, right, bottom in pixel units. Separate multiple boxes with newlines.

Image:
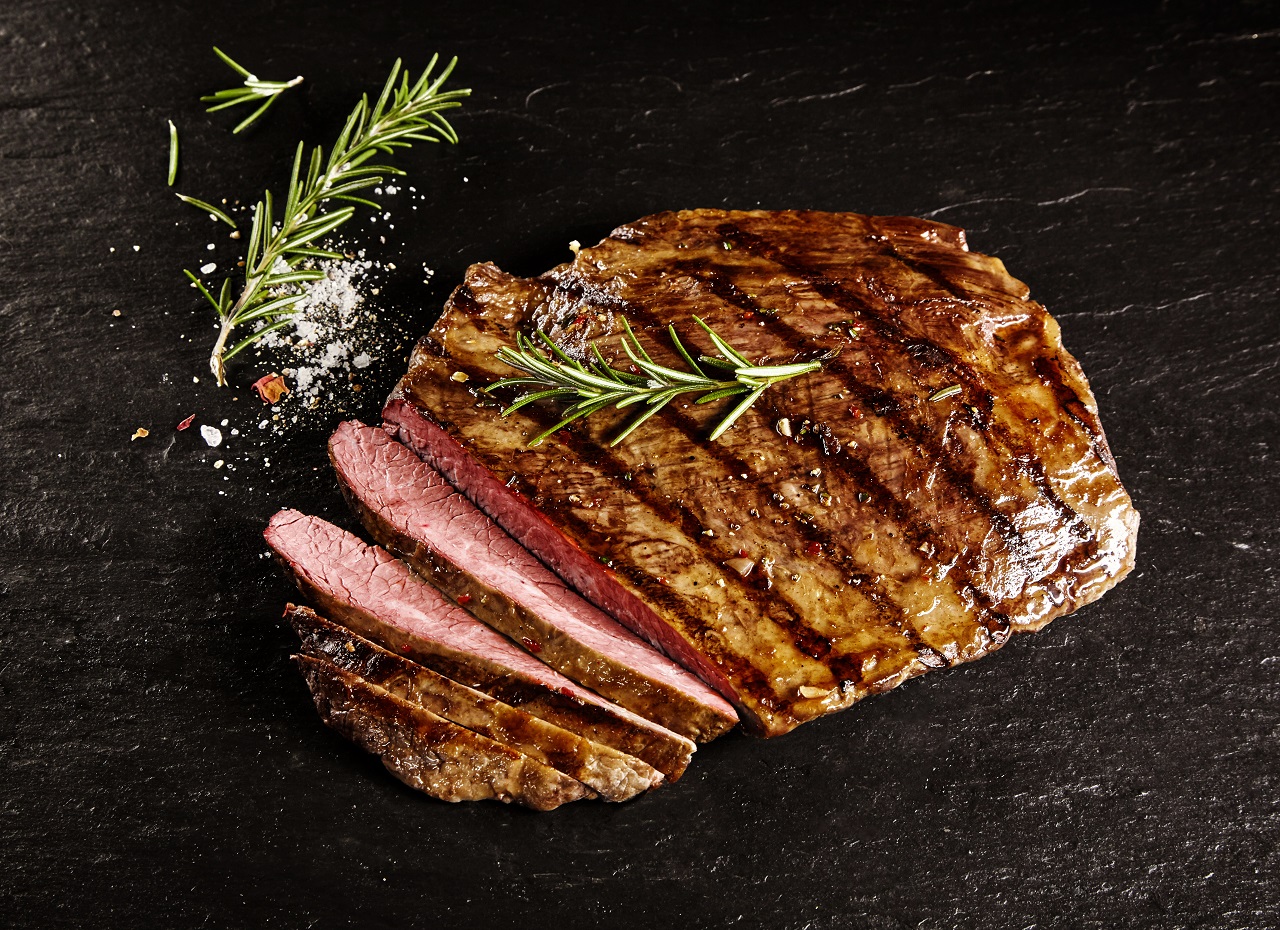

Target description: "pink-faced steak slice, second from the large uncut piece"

left=264, top=510, right=696, bottom=782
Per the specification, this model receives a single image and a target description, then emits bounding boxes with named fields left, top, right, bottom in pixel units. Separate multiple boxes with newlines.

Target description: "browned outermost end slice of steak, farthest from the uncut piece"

left=293, top=655, right=594, bottom=811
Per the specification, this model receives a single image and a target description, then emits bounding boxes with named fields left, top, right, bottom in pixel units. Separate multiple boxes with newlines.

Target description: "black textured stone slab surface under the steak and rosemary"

left=0, top=0, right=1280, bottom=930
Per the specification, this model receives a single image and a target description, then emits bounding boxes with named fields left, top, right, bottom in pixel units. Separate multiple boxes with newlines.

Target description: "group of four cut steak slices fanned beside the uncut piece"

left=265, top=422, right=737, bottom=810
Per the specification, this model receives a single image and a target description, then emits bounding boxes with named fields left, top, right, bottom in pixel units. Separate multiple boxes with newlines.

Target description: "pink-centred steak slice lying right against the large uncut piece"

left=329, top=422, right=737, bottom=741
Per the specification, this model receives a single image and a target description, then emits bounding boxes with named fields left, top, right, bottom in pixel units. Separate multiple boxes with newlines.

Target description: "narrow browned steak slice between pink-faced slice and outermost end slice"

left=284, top=604, right=663, bottom=801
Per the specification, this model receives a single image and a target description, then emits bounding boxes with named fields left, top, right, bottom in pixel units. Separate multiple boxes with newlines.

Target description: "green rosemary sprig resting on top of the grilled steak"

left=484, top=316, right=826, bottom=446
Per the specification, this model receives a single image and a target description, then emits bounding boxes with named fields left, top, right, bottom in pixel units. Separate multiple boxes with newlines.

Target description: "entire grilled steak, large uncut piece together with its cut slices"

left=268, top=210, right=1138, bottom=807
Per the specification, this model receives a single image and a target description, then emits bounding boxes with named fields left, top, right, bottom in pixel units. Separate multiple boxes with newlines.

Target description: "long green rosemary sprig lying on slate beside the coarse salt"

left=184, top=55, right=471, bottom=385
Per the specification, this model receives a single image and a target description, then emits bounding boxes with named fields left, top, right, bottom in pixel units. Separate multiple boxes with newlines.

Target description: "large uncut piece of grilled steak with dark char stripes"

left=384, top=210, right=1138, bottom=734
